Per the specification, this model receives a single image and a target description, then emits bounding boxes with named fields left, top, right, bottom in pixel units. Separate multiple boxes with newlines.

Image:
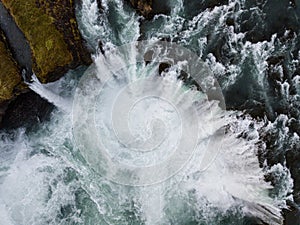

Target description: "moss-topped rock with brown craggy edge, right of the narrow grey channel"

left=2, top=0, right=91, bottom=82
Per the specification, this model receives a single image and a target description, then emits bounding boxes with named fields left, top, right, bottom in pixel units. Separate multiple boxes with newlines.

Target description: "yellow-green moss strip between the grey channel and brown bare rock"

left=2, top=0, right=73, bottom=81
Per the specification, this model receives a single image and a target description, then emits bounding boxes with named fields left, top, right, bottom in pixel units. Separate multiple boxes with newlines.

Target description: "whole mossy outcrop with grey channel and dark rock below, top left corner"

left=0, top=0, right=91, bottom=128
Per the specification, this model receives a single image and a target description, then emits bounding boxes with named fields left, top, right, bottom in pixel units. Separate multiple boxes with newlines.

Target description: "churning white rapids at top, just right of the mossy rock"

left=77, top=0, right=140, bottom=50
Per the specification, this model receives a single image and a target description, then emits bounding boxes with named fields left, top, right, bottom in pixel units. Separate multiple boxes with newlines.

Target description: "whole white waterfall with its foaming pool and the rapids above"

left=0, top=0, right=299, bottom=225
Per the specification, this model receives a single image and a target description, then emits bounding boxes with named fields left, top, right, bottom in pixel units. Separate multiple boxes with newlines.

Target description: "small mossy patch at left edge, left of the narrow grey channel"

left=0, top=40, right=21, bottom=103
